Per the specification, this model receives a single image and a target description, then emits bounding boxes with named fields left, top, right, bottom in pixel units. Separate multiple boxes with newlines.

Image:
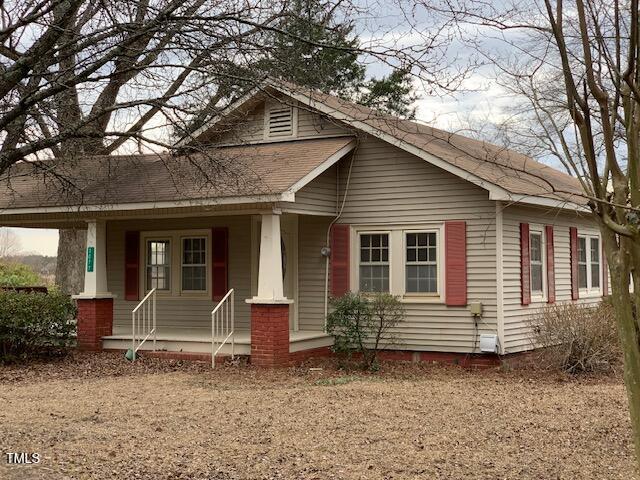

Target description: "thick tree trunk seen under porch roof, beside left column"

left=56, top=229, right=87, bottom=295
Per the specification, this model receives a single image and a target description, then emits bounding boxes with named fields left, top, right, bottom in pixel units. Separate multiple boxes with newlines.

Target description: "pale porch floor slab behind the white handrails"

left=102, top=327, right=333, bottom=355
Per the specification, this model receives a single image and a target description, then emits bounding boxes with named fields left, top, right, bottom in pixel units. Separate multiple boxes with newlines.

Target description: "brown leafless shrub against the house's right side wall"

left=531, top=302, right=622, bottom=373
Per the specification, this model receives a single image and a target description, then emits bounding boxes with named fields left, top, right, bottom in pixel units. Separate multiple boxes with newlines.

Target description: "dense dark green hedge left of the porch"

left=0, top=291, right=76, bottom=362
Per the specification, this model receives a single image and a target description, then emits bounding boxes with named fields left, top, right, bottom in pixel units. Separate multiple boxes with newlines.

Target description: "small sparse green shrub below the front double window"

left=327, top=293, right=404, bottom=370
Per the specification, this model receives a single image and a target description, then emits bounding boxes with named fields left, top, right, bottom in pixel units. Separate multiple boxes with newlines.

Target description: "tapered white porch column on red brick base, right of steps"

left=247, top=211, right=293, bottom=367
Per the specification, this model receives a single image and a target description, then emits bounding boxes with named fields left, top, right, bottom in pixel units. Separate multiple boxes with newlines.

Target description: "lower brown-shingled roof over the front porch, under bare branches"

left=0, top=137, right=356, bottom=214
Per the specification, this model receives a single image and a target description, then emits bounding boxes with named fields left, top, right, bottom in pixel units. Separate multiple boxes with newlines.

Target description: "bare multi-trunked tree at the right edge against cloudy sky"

left=419, top=0, right=640, bottom=459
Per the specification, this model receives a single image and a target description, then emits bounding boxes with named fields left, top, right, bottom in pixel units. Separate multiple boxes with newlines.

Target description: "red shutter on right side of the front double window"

left=444, top=221, right=467, bottom=307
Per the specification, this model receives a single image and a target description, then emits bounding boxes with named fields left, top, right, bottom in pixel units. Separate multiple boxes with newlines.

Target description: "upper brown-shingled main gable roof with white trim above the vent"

left=183, top=80, right=586, bottom=209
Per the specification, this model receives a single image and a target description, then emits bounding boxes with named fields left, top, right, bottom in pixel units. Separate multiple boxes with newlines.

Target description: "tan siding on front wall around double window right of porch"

left=338, top=137, right=497, bottom=352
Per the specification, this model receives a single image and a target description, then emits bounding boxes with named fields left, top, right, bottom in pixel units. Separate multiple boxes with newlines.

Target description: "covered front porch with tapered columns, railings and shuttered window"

left=71, top=208, right=333, bottom=366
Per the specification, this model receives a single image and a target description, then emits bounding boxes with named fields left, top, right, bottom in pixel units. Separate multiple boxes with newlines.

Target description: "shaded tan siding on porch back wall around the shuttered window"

left=107, top=216, right=251, bottom=333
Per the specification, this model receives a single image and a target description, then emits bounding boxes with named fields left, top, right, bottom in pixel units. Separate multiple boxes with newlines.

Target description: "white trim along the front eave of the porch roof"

left=0, top=191, right=295, bottom=216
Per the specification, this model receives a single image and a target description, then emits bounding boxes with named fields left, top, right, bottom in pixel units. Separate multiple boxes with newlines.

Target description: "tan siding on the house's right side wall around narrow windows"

left=503, top=205, right=601, bottom=353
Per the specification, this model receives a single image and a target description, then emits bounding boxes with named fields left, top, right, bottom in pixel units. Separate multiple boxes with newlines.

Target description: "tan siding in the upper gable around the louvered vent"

left=216, top=98, right=349, bottom=144
